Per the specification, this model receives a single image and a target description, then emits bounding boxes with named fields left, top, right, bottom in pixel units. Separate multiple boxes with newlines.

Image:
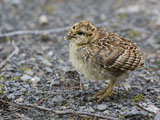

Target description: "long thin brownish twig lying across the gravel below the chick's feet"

left=0, top=100, right=117, bottom=120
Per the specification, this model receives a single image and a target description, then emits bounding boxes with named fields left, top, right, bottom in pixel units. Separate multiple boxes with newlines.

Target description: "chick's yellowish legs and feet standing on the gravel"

left=93, top=80, right=116, bottom=102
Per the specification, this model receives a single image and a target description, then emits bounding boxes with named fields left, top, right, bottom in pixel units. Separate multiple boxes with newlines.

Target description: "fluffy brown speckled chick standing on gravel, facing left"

left=64, top=21, right=144, bottom=102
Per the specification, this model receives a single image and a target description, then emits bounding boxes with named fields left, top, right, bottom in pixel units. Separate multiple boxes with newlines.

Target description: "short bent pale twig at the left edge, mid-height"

left=0, top=42, right=19, bottom=69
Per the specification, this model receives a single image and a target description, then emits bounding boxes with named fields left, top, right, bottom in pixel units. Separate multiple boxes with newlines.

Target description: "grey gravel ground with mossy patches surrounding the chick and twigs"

left=0, top=0, right=160, bottom=120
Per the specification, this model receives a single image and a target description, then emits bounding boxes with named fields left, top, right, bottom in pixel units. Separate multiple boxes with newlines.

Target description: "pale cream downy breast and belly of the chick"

left=70, top=43, right=112, bottom=80
